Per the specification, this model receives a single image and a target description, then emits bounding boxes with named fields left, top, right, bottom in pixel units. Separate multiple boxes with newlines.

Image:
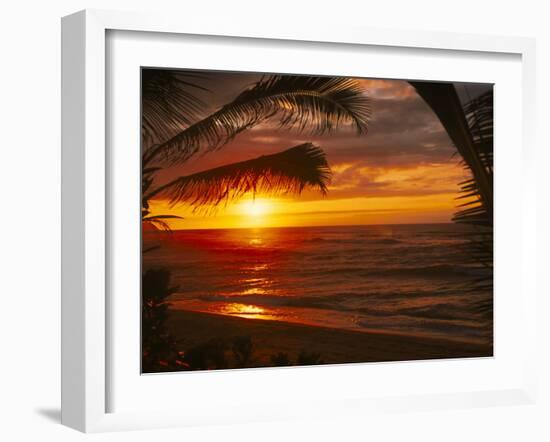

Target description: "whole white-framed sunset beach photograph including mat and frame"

left=62, top=11, right=536, bottom=432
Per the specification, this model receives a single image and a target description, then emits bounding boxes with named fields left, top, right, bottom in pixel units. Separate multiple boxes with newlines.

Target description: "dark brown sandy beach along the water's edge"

left=168, top=310, right=493, bottom=367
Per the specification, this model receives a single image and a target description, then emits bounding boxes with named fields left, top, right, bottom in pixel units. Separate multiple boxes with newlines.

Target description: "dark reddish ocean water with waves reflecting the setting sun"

left=143, top=224, right=493, bottom=343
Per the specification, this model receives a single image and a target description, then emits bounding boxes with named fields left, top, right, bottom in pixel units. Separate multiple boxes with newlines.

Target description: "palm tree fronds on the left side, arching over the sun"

left=142, top=69, right=370, bottom=228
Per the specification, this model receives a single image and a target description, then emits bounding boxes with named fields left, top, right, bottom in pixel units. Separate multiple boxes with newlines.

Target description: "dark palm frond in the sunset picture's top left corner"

left=141, top=68, right=207, bottom=145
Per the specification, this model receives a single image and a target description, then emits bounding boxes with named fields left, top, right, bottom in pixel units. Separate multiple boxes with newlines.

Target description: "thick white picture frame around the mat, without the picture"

left=62, top=10, right=536, bottom=432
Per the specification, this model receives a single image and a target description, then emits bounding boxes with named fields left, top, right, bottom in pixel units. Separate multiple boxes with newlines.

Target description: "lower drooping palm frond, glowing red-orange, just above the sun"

left=144, top=143, right=331, bottom=208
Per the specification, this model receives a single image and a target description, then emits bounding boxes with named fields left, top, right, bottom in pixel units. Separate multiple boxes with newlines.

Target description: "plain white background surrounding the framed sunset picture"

left=0, top=0, right=550, bottom=442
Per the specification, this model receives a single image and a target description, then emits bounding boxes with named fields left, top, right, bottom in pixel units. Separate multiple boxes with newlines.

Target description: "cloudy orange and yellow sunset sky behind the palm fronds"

left=147, top=72, right=490, bottom=229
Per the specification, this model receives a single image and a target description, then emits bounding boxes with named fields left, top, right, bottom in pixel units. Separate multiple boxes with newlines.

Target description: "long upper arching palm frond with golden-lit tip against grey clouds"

left=144, top=75, right=370, bottom=164
